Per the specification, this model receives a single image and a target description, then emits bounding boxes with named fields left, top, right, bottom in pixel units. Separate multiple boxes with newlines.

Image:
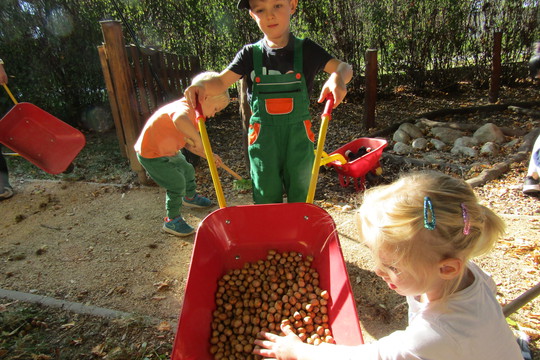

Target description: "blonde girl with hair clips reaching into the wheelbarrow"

left=254, top=172, right=523, bottom=360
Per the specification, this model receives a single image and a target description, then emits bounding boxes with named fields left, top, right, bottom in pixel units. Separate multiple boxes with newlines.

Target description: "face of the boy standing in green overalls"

left=249, top=0, right=298, bottom=40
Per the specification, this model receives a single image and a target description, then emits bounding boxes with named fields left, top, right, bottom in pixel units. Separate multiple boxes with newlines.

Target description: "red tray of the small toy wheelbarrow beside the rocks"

left=328, top=138, right=387, bottom=178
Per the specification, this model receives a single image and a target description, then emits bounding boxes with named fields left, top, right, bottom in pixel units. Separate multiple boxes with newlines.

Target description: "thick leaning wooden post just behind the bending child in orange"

left=100, top=20, right=148, bottom=183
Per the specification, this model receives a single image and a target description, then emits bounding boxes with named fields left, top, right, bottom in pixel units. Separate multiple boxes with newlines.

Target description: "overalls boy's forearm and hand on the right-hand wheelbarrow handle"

left=318, top=59, right=353, bottom=108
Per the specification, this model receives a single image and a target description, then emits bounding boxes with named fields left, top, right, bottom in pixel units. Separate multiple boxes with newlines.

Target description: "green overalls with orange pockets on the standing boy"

left=248, top=38, right=315, bottom=204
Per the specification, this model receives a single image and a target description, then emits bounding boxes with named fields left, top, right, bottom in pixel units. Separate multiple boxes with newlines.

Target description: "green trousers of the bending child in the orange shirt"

left=137, top=154, right=186, bottom=219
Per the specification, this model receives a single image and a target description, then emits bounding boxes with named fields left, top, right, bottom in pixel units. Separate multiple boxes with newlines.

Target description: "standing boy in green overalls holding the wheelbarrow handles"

left=185, top=0, right=353, bottom=204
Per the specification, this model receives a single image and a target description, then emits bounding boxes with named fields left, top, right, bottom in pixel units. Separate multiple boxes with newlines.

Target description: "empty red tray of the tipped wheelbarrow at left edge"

left=0, top=102, right=86, bottom=174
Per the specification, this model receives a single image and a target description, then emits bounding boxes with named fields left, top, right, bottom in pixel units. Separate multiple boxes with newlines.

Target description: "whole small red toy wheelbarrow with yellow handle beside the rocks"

left=323, top=138, right=388, bottom=191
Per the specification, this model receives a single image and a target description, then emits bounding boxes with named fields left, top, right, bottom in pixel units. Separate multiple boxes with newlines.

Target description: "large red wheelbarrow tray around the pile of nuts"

left=172, top=203, right=363, bottom=360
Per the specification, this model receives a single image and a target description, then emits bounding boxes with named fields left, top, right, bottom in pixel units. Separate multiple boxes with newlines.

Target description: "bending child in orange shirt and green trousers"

left=135, top=72, right=229, bottom=236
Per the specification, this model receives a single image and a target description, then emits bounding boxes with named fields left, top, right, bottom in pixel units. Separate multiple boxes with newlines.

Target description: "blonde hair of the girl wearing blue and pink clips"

left=357, top=171, right=505, bottom=298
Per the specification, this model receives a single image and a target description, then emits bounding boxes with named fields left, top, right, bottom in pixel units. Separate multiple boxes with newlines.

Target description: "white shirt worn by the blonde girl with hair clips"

left=356, top=262, right=523, bottom=360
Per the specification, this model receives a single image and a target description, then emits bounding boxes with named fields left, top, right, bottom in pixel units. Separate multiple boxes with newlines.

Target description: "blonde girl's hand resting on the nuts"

left=253, top=325, right=306, bottom=360
